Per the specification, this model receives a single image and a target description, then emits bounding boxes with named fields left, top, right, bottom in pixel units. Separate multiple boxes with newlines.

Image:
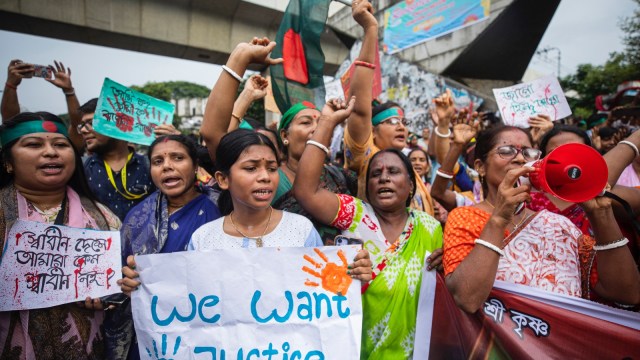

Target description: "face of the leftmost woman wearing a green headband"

left=10, top=133, right=76, bottom=191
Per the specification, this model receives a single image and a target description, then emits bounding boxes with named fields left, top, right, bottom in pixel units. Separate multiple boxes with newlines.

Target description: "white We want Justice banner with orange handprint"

left=131, top=246, right=362, bottom=360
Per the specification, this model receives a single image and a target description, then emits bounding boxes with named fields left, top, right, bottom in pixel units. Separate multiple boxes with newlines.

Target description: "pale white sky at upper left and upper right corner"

left=0, top=0, right=635, bottom=114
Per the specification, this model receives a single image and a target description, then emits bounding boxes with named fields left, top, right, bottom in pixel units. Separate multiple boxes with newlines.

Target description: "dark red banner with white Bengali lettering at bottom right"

left=430, top=275, right=640, bottom=360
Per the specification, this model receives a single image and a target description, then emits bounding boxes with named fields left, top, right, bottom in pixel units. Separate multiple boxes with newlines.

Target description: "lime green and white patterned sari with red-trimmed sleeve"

left=332, top=195, right=442, bottom=359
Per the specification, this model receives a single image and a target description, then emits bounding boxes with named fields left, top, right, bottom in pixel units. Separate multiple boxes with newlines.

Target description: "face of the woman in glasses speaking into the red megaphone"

left=476, top=130, right=532, bottom=188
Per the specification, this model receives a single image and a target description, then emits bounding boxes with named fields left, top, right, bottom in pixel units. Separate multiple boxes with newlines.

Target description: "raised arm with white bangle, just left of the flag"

left=200, top=38, right=282, bottom=161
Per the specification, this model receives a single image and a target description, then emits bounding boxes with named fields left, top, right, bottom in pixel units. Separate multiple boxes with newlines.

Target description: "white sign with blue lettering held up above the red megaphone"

left=493, top=76, right=571, bottom=128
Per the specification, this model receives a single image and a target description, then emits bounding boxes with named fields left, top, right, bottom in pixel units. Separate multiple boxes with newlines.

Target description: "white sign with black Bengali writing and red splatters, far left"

left=0, top=220, right=122, bottom=311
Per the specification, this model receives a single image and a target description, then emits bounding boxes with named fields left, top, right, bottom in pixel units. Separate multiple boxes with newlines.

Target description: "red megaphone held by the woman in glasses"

left=529, top=144, right=609, bottom=203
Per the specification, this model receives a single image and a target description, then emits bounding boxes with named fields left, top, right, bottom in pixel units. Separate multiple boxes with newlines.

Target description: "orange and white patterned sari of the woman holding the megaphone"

left=443, top=206, right=597, bottom=299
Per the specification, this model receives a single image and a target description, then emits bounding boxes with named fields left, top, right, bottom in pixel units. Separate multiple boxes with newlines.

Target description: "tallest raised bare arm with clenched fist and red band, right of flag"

left=347, top=0, right=378, bottom=144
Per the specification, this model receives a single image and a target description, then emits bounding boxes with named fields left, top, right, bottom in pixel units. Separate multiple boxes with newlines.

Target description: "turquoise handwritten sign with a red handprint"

left=93, top=78, right=175, bottom=145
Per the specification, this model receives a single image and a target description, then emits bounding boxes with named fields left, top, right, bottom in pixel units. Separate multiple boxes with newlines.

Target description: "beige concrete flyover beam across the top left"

left=0, top=0, right=355, bottom=75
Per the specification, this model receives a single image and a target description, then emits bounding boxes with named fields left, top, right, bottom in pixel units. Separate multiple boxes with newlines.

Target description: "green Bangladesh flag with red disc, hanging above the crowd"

left=271, top=0, right=331, bottom=113
